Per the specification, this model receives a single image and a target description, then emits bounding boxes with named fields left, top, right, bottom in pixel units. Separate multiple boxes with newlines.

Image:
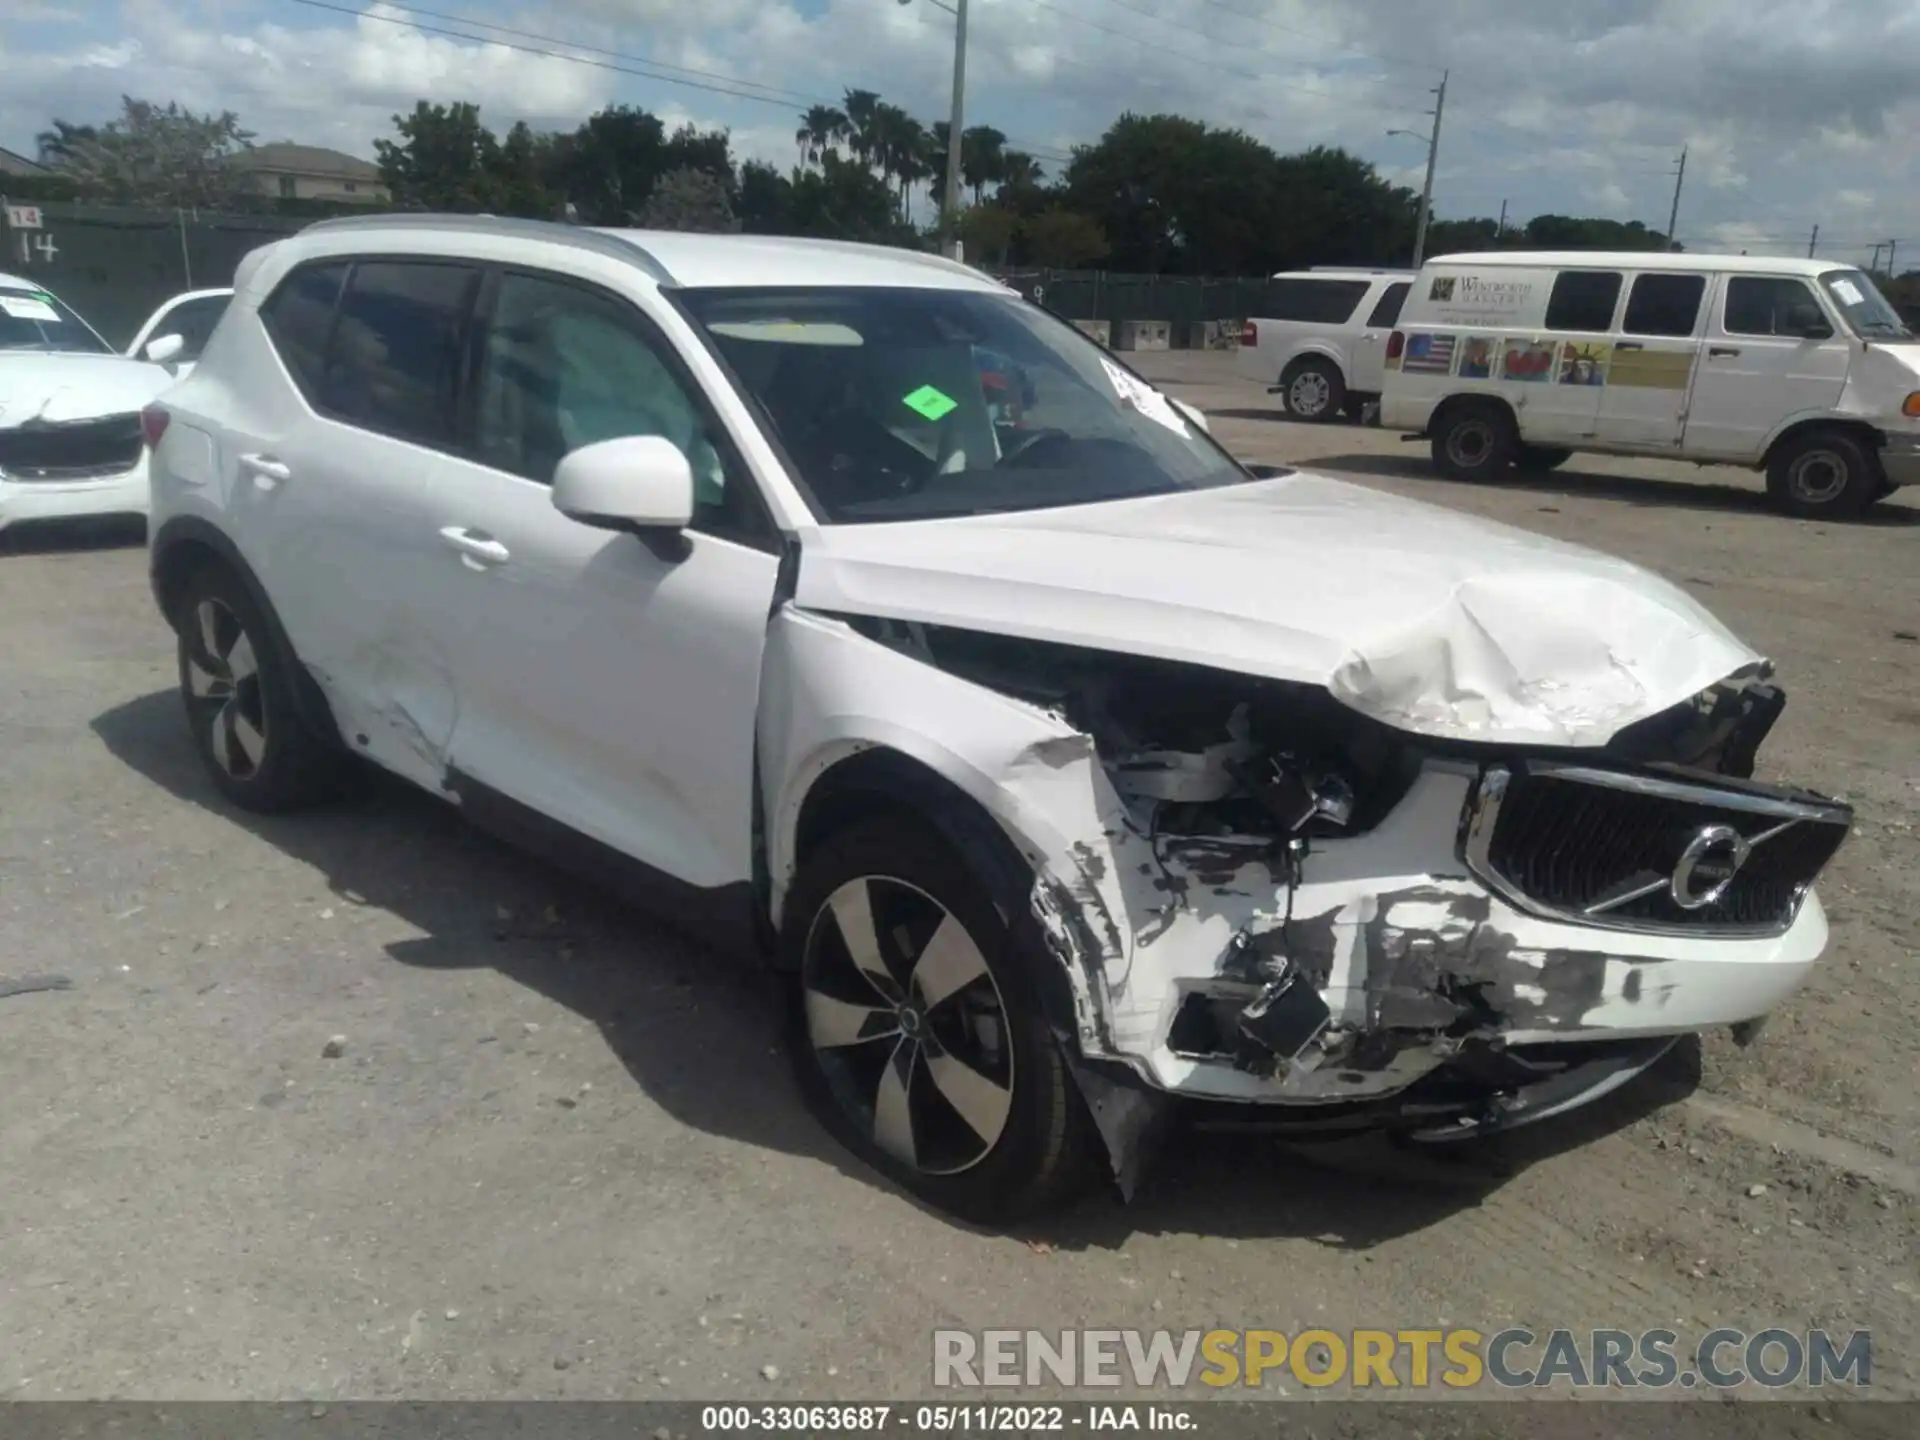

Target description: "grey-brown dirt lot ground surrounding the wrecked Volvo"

left=0, top=355, right=1920, bottom=1434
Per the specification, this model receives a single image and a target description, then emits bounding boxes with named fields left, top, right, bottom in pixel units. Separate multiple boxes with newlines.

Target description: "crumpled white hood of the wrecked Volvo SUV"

left=795, top=472, right=1761, bottom=745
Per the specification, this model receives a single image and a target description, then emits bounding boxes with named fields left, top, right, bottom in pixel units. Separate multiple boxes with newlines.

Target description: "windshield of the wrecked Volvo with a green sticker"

left=678, top=288, right=1250, bottom=524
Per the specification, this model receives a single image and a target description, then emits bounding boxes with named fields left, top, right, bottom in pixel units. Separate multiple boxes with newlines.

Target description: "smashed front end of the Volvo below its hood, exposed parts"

left=847, top=618, right=1851, bottom=1160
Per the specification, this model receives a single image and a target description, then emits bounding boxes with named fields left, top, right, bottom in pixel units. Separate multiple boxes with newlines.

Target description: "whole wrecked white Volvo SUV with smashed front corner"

left=146, top=215, right=1851, bottom=1221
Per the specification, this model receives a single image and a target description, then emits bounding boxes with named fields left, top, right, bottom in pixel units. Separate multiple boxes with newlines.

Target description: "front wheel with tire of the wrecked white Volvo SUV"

left=781, top=816, right=1098, bottom=1225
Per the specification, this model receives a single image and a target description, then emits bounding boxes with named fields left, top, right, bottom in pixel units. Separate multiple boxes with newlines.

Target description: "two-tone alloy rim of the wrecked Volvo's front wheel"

left=803, top=876, right=1014, bottom=1175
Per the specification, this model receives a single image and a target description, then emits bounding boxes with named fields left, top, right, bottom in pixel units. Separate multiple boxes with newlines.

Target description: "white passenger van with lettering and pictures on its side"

left=1380, top=252, right=1920, bottom=516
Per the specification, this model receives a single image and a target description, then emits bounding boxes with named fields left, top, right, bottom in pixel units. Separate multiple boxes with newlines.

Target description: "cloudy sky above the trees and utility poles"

left=0, top=0, right=1920, bottom=269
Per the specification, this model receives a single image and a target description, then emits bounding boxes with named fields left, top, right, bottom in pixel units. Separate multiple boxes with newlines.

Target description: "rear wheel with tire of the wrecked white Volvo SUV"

left=173, top=566, right=342, bottom=814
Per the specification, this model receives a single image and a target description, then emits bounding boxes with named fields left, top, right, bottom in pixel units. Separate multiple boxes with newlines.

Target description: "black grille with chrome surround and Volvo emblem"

left=1463, top=762, right=1853, bottom=937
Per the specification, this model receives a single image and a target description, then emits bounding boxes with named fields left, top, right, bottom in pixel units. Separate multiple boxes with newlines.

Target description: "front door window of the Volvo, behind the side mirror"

left=474, top=273, right=768, bottom=541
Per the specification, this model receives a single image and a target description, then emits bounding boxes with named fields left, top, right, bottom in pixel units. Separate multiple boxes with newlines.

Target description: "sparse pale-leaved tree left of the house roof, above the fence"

left=36, top=96, right=253, bottom=207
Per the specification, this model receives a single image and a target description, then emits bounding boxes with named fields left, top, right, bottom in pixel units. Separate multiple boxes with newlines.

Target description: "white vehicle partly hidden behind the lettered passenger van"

left=1238, top=265, right=1413, bottom=420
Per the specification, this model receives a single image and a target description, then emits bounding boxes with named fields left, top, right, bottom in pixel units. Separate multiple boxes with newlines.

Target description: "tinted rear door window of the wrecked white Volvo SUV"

left=319, top=259, right=480, bottom=445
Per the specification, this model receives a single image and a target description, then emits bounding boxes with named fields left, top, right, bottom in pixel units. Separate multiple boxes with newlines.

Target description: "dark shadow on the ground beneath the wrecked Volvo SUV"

left=92, top=691, right=1699, bottom=1250
